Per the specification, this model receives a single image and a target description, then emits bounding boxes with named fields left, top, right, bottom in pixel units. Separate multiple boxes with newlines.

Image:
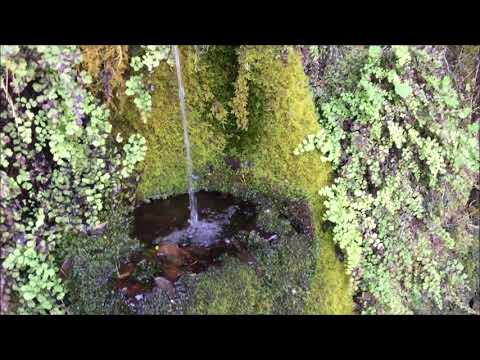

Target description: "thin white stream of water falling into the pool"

left=173, top=45, right=198, bottom=226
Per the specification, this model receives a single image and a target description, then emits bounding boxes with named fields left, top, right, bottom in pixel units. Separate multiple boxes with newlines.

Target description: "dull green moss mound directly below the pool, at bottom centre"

left=186, top=257, right=271, bottom=314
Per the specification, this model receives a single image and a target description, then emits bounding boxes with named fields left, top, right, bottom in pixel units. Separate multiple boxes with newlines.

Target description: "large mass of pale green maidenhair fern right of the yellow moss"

left=294, top=46, right=479, bottom=313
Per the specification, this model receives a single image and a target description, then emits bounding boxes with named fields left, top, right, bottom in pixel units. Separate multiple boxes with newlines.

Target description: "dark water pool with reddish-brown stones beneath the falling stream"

left=115, top=191, right=260, bottom=301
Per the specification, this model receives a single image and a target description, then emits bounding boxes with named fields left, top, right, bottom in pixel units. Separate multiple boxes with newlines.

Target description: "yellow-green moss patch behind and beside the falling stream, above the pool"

left=115, top=47, right=231, bottom=198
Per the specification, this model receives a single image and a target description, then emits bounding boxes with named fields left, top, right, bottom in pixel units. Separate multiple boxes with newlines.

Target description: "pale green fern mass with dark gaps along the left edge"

left=0, top=46, right=146, bottom=313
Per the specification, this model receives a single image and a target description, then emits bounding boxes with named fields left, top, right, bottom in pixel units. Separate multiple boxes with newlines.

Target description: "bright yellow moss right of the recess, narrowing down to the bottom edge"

left=227, top=46, right=353, bottom=314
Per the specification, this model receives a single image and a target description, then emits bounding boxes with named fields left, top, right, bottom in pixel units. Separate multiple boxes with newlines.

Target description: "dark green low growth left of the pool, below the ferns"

left=63, top=206, right=139, bottom=315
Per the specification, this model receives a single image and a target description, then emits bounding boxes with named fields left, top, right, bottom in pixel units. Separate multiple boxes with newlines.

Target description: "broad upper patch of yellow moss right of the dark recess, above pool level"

left=233, top=46, right=330, bottom=195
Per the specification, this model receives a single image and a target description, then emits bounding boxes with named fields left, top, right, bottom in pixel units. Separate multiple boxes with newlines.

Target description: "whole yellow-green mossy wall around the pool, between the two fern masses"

left=108, top=46, right=353, bottom=314
